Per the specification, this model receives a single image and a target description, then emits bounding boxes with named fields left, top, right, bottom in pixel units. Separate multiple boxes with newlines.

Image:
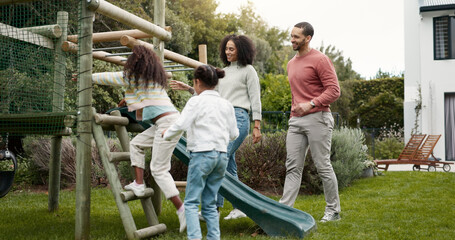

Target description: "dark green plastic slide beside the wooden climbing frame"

left=174, top=137, right=316, bottom=238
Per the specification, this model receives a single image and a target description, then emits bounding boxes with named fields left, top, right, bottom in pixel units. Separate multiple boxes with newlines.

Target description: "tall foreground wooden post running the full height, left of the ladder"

left=75, top=0, right=94, bottom=240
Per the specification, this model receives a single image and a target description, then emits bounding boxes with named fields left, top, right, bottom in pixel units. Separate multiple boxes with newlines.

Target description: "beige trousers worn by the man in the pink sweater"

left=280, top=112, right=341, bottom=213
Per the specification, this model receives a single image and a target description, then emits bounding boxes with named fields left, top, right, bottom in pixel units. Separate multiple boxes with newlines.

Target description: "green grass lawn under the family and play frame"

left=0, top=172, right=455, bottom=240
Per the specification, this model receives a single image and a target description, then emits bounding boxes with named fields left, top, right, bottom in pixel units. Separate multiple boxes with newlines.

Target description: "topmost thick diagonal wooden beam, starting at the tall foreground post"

left=88, top=0, right=172, bottom=41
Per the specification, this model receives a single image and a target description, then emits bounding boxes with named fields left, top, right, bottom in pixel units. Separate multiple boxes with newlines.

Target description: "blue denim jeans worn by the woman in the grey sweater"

left=216, top=107, right=250, bottom=208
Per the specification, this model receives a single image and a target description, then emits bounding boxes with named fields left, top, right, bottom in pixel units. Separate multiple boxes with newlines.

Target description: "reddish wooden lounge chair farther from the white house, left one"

left=374, top=134, right=427, bottom=171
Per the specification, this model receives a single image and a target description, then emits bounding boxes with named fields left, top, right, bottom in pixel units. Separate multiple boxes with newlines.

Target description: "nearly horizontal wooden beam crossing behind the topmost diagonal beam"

left=68, top=27, right=171, bottom=43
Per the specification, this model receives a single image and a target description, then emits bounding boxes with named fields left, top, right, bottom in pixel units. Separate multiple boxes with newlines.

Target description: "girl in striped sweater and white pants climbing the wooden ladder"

left=92, top=45, right=186, bottom=232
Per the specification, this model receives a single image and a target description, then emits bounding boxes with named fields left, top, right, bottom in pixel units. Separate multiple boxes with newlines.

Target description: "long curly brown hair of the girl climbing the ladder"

left=123, top=45, right=167, bottom=88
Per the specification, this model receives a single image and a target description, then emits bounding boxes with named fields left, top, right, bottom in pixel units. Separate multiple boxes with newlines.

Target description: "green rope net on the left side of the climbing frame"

left=0, top=0, right=79, bottom=136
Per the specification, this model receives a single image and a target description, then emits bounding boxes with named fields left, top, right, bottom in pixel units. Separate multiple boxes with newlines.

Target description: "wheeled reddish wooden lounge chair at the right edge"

left=412, top=134, right=453, bottom=172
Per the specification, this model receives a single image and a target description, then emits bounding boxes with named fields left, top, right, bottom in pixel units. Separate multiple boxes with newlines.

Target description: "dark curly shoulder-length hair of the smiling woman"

left=220, top=34, right=256, bottom=66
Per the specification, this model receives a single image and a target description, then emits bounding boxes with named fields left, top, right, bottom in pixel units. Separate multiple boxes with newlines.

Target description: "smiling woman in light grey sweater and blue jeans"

left=170, top=35, right=262, bottom=220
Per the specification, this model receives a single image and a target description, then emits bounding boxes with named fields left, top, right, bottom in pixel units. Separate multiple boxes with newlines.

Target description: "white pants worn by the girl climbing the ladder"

left=130, top=113, right=180, bottom=199
